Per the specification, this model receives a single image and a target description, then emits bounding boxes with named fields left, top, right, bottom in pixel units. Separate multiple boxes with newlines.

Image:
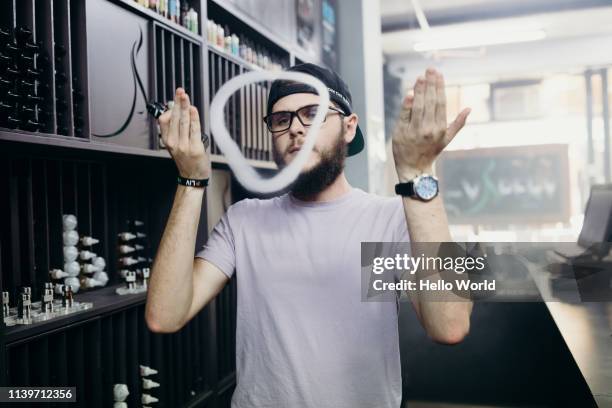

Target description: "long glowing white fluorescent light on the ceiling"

left=414, top=30, right=546, bottom=52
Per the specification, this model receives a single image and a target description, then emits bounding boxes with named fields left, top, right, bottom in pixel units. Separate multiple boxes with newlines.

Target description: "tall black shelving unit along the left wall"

left=0, top=0, right=338, bottom=408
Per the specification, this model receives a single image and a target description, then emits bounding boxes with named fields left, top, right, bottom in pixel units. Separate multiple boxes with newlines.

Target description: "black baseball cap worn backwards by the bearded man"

left=268, top=63, right=365, bottom=156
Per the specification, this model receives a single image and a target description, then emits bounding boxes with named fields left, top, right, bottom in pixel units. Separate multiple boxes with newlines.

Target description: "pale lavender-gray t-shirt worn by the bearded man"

left=196, top=188, right=408, bottom=408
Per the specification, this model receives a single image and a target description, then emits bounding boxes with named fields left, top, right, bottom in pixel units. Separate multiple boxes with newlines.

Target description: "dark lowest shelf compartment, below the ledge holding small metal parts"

left=6, top=287, right=215, bottom=408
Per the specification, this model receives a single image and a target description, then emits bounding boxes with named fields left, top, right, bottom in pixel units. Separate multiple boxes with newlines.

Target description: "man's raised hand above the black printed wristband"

left=158, top=88, right=210, bottom=179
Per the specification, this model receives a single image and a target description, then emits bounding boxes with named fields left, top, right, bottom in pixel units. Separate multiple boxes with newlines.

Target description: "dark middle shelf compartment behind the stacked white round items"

left=0, top=145, right=176, bottom=318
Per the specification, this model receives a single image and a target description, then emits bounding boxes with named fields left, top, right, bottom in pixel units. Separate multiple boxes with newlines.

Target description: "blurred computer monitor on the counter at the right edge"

left=578, top=184, right=612, bottom=253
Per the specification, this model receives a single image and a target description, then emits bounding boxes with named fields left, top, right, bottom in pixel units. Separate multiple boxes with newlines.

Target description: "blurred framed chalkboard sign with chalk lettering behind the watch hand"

left=436, top=145, right=570, bottom=225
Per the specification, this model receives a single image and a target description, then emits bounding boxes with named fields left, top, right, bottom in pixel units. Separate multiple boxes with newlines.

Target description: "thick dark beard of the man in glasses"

left=274, top=129, right=348, bottom=199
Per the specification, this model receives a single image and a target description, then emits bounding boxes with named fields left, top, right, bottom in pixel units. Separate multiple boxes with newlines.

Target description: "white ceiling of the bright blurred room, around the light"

left=380, top=0, right=612, bottom=83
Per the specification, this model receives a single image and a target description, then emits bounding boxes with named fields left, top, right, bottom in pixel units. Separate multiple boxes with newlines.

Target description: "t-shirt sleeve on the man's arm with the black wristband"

left=196, top=207, right=236, bottom=278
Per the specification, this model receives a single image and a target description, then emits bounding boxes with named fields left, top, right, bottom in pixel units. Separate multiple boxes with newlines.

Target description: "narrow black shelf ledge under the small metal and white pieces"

left=4, top=284, right=146, bottom=346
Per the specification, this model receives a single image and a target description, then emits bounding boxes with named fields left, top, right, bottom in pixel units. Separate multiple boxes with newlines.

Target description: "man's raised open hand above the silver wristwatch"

left=392, top=68, right=471, bottom=182
